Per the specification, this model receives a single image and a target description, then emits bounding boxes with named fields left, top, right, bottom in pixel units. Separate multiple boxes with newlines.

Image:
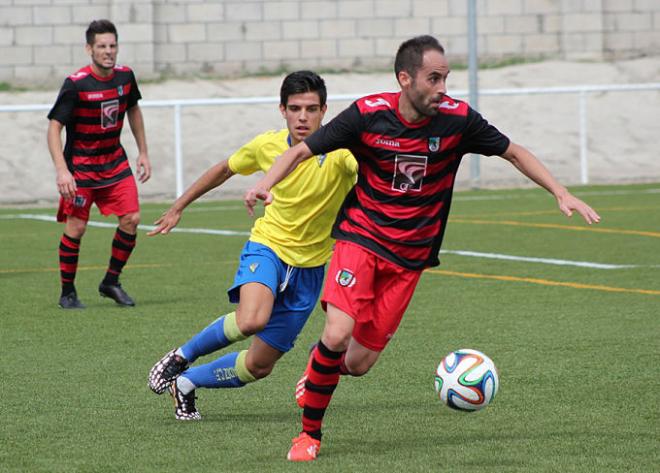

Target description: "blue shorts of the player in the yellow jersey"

left=227, top=240, right=324, bottom=352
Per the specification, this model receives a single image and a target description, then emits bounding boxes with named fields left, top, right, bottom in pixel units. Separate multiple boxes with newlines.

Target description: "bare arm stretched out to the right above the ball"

left=502, top=142, right=600, bottom=225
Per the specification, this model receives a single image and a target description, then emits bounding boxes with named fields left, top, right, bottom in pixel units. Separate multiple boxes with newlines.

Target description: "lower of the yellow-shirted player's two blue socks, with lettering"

left=177, top=350, right=257, bottom=394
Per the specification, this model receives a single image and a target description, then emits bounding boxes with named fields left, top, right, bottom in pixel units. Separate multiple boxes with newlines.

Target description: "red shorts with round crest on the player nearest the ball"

left=321, top=241, right=422, bottom=351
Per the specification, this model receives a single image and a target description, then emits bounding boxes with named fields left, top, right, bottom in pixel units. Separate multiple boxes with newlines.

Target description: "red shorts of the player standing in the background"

left=57, top=176, right=140, bottom=222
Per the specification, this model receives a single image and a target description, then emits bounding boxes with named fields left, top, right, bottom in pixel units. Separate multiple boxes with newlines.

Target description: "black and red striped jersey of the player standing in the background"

left=48, top=66, right=142, bottom=187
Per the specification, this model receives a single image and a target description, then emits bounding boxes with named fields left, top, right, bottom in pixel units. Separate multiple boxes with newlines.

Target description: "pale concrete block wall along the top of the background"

left=0, top=0, right=660, bottom=84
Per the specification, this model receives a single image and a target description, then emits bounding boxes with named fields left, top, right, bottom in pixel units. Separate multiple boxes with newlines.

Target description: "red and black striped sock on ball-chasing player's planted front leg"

left=302, top=341, right=345, bottom=440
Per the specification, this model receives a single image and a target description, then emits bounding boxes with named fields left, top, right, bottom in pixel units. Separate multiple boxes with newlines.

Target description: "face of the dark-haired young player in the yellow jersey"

left=280, top=92, right=327, bottom=145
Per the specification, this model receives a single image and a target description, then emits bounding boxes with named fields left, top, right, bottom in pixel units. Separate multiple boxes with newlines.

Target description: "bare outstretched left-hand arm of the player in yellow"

left=147, top=159, right=234, bottom=236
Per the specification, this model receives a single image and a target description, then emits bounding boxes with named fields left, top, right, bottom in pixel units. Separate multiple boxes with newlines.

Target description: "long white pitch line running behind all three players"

left=0, top=214, right=656, bottom=269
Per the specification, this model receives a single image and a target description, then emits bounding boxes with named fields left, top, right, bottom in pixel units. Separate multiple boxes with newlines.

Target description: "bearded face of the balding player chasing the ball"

left=408, top=50, right=449, bottom=117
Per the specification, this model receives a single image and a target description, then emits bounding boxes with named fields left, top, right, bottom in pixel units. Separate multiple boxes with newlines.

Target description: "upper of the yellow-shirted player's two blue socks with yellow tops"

left=179, top=312, right=247, bottom=363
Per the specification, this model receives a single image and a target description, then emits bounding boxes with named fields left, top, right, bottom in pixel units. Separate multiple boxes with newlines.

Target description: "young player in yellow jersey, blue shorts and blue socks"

left=148, top=71, right=357, bottom=420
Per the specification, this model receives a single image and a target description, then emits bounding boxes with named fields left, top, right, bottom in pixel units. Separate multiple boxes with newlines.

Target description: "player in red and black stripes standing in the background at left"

left=48, top=20, right=151, bottom=309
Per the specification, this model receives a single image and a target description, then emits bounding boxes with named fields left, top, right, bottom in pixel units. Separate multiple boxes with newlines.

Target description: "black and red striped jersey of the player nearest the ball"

left=305, top=92, right=509, bottom=270
